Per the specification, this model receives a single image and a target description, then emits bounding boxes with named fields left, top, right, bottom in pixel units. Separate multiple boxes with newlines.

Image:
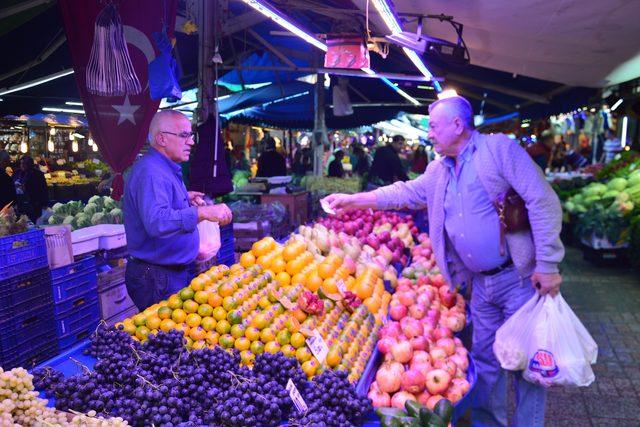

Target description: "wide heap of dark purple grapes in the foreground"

left=32, top=329, right=371, bottom=427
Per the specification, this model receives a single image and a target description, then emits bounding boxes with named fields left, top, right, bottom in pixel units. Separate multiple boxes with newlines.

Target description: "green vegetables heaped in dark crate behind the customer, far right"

left=563, top=170, right=640, bottom=244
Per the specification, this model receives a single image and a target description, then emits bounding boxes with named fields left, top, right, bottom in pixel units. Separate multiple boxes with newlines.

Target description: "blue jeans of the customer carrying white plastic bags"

left=471, top=266, right=546, bottom=427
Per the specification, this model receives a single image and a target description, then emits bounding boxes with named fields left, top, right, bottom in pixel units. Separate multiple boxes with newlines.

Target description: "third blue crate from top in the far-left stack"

left=0, top=302, right=55, bottom=359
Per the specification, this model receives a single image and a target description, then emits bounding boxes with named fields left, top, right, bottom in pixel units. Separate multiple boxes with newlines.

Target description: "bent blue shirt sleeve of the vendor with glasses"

left=136, top=177, right=198, bottom=237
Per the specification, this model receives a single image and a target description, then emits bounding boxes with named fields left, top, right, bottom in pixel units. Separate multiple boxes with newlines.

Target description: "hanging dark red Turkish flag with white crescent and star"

left=58, top=0, right=178, bottom=200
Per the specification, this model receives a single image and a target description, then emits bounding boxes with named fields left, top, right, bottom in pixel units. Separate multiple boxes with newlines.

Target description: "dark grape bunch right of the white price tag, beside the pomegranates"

left=290, top=370, right=373, bottom=427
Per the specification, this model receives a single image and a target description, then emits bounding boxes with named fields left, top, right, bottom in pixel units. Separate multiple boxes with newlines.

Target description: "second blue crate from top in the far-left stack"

left=0, top=267, right=53, bottom=322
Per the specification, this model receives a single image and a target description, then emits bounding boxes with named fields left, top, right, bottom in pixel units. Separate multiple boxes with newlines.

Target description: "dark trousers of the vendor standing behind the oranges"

left=124, top=259, right=193, bottom=311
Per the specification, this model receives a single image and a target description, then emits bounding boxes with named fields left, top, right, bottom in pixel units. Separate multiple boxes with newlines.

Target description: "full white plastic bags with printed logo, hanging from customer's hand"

left=493, top=294, right=598, bottom=387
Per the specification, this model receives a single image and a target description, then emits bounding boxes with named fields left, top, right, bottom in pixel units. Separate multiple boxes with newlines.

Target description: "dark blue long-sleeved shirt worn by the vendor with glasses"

left=123, top=148, right=200, bottom=265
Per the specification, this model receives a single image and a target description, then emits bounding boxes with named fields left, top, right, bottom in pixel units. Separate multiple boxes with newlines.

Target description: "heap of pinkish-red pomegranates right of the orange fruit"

left=369, top=234, right=470, bottom=410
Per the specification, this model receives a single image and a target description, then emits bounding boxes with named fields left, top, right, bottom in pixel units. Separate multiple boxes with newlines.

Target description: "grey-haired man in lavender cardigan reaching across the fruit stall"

left=326, top=97, right=564, bottom=426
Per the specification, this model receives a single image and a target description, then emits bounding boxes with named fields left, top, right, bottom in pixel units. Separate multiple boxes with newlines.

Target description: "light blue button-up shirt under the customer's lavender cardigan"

left=444, top=140, right=509, bottom=272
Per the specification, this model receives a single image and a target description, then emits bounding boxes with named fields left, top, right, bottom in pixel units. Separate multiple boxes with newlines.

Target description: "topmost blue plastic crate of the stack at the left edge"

left=0, top=230, right=48, bottom=280
